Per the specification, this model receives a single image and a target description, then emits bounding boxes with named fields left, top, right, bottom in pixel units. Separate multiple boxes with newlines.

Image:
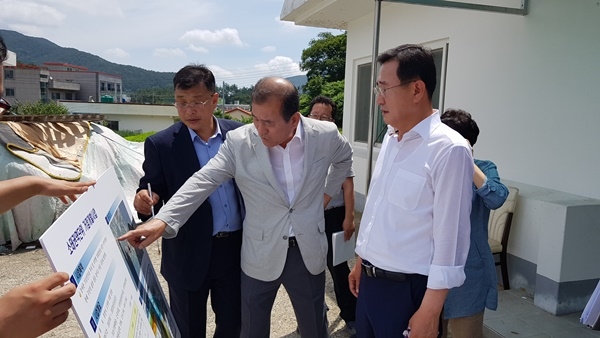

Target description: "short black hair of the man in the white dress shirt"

left=377, top=44, right=437, bottom=100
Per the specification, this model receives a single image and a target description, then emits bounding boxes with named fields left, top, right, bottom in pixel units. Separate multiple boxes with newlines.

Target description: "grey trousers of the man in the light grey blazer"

left=241, top=246, right=328, bottom=338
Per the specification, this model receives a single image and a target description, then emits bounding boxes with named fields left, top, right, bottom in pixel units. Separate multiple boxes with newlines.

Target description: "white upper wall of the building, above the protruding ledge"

left=343, top=0, right=600, bottom=198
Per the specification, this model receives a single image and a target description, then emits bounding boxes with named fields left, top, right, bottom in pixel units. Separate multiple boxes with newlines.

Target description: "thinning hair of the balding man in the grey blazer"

left=252, top=77, right=300, bottom=122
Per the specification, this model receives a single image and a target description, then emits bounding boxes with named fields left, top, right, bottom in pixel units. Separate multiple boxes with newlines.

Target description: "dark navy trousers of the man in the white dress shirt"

left=356, top=271, right=442, bottom=338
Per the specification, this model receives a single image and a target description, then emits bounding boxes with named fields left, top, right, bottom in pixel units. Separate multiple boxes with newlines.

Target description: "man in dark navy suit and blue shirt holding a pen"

left=134, top=65, right=244, bottom=337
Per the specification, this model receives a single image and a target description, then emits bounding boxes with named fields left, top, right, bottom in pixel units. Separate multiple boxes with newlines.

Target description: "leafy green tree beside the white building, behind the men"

left=300, top=32, right=347, bottom=126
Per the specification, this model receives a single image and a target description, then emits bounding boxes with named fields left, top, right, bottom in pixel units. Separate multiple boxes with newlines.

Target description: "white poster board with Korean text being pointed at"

left=40, top=167, right=181, bottom=337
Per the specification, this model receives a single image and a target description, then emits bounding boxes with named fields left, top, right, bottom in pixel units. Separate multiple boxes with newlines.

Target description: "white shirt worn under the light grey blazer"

left=269, top=119, right=304, bottom=236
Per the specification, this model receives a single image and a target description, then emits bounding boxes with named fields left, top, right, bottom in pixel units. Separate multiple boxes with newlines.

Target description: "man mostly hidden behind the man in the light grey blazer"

left=308, top=95, right=356, bottom=335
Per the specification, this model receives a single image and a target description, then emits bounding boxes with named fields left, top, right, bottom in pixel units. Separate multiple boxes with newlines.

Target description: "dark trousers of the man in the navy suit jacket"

left=169, top=230, right=242, bottom=338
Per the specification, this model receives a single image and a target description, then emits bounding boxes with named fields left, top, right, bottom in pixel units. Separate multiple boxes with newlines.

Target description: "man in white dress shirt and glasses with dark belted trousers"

left=349, top=45, right=473, bottom=338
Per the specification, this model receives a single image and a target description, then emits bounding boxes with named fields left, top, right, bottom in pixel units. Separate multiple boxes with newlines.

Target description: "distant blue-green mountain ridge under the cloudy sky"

left=0, top=29, right=306, bottom=93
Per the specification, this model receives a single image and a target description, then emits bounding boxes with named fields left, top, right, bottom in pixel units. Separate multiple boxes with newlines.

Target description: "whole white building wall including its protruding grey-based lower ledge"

left=343, top=0, right=600, bottom=314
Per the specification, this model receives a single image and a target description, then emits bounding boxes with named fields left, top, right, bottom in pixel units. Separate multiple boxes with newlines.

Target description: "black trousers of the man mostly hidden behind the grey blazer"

left=325, top=206, right=356, bottom=323
